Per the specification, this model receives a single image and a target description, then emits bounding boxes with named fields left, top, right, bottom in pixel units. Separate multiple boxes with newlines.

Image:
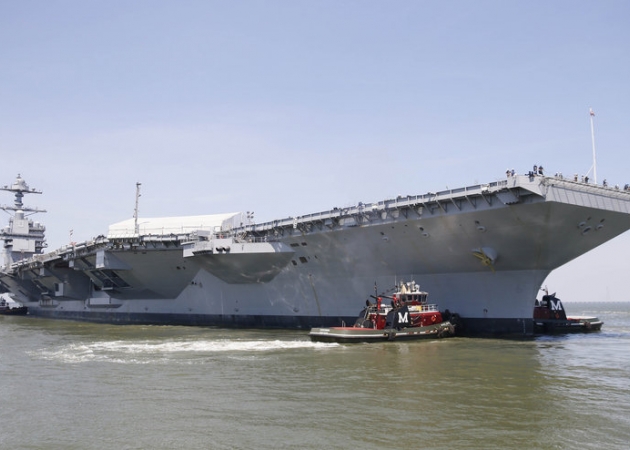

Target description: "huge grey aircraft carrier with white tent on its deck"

left=0, top=172, right=630, bottom=335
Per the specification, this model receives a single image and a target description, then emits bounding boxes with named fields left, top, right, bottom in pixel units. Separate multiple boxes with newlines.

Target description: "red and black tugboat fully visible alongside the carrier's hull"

left=309, top=281, right=458, bottom=342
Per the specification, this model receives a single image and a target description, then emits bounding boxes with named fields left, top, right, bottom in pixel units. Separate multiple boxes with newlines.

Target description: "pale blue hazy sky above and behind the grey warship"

left=0, top=0, right=630, bottom=301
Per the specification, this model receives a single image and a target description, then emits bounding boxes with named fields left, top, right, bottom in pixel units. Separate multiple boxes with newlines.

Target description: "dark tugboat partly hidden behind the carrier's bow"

left=534, top=288, right=604, bottom=334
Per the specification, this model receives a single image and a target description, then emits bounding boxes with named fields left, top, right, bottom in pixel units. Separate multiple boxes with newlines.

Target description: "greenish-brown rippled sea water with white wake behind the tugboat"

left=0, top=303, right=630, bottom=450
